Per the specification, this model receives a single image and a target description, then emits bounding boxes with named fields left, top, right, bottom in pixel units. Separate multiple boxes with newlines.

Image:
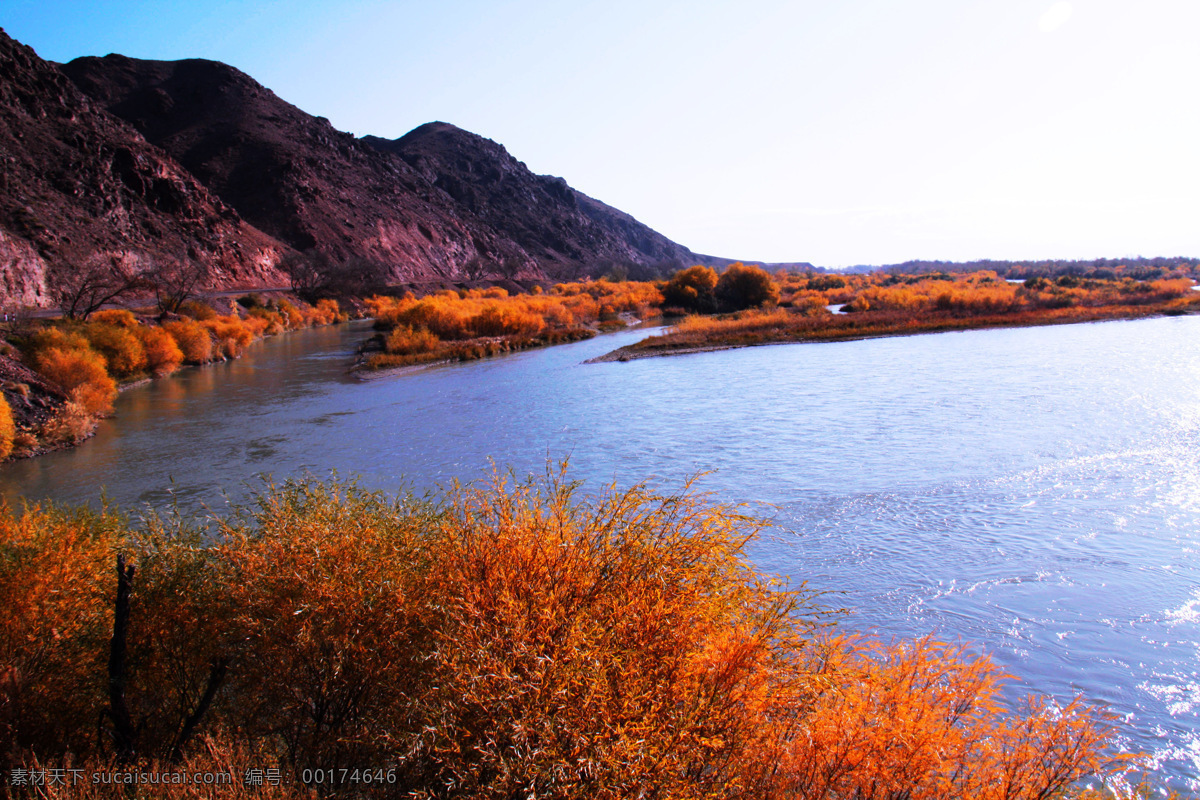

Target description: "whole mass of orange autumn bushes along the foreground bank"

left=0, top=474, right=1117, bottom=800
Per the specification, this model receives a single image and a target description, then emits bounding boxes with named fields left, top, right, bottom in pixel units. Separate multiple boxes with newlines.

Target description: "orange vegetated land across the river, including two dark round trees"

left=596, top=264, right=1200, bottom=361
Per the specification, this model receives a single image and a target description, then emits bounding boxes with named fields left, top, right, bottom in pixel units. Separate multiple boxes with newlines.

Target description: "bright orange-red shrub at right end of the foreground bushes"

left=756, top=638, right=1128, bottom=800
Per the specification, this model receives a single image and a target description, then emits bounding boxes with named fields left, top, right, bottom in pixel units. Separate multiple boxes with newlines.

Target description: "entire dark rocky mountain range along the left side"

left=0, top=24, right=724, bottom=307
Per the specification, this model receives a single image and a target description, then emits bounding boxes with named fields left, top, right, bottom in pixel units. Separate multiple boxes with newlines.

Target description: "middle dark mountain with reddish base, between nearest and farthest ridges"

left=62, top=55, right=536, bottom=281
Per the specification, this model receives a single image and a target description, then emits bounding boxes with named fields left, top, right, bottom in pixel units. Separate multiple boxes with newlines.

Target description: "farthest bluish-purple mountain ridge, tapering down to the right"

left=362, top=122, right=708, bottom=273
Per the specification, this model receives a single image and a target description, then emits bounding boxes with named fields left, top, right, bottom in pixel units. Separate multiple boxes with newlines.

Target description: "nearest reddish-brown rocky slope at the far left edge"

left=0, top=30, right=287, bottom=308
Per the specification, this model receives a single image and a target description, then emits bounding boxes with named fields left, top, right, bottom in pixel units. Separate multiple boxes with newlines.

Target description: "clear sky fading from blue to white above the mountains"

left=0, top=0, right=1200, bottom=266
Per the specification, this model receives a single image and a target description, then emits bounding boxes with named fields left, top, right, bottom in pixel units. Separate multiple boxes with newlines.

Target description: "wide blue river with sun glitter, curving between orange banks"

left=0, top=317, right=1200, bottom=789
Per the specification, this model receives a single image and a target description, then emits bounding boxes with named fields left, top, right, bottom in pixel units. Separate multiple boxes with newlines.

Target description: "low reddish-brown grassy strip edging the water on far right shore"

left=587, top=296, right=1200, bottom=363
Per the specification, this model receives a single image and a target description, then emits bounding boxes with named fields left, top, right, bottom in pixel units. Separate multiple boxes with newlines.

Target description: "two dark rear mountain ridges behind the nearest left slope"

left=62, top=55, right=695, bottom=281
